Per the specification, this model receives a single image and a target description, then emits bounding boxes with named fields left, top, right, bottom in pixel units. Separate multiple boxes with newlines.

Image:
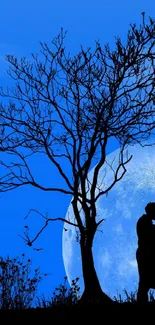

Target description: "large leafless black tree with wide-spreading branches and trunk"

left=0, top=13, right=155, bottom=302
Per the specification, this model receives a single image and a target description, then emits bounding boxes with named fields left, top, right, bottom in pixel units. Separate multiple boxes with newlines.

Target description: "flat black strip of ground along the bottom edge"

left=0, top=303, right=155, bottom=325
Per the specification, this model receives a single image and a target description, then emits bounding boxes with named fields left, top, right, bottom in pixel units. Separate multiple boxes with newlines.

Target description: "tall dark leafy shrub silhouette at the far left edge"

left=0, top=254, right=42, bottom=309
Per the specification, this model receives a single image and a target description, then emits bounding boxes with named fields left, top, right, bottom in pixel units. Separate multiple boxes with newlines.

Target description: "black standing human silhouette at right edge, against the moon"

left=136, top=202, right=155, bottom=303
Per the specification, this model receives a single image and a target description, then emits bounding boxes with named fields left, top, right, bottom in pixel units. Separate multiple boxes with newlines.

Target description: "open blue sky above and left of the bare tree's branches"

left=0, top=0, right=155, bottom=302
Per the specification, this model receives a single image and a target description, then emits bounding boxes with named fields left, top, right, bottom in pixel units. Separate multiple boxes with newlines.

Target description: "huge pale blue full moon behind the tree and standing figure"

left=62, top=144, right=155, bottom=298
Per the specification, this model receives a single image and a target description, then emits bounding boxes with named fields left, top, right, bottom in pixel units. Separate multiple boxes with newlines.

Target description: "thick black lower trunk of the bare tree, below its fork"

left=80, top=235, right=114, bottom=303
